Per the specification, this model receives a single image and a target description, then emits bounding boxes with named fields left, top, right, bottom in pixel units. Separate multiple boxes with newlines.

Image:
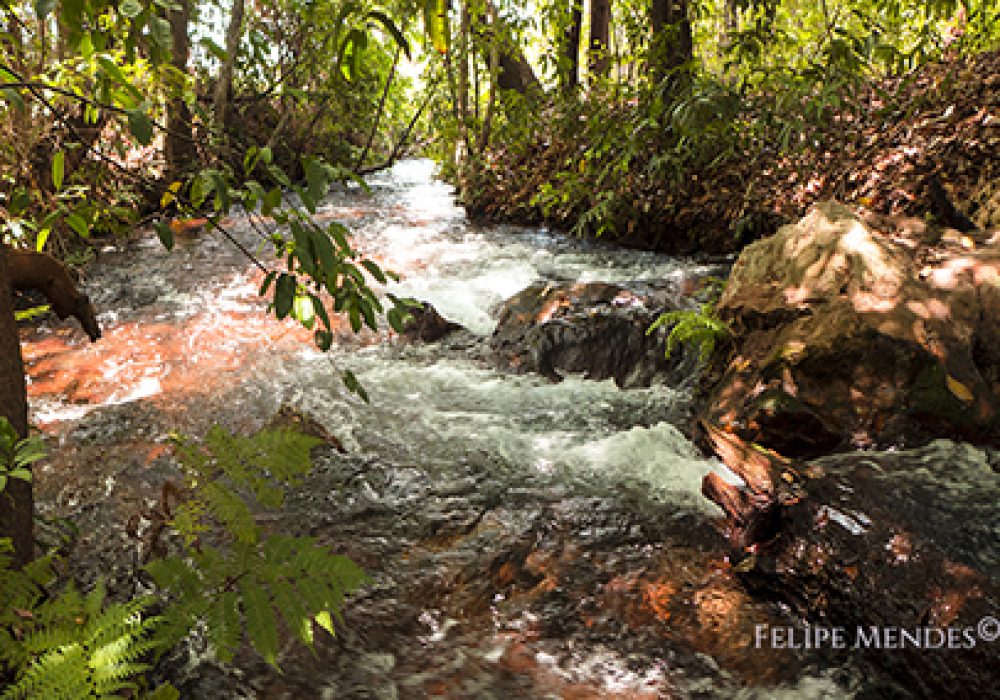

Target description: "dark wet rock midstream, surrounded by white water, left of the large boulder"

left=490, top=282, right=692, bottom=387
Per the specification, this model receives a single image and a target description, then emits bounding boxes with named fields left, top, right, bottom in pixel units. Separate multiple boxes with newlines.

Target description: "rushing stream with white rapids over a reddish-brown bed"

left=24, top=160, right=997, bottom=698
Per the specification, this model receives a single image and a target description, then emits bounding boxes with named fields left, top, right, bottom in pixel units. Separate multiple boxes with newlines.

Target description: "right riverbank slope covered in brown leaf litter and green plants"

left=463, top=52, right=1000, bottom=253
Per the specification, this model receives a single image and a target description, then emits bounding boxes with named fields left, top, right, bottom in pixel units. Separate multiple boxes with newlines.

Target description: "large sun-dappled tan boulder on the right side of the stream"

left=697, top=202, right=1000, bottom=456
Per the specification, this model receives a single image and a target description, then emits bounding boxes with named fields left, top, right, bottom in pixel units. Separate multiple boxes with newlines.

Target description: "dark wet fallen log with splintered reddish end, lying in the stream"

left=702, top=424, right=1000, bottom=697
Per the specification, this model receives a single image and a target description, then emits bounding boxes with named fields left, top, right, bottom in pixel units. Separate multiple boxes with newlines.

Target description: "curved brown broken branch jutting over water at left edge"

left=2, top=248, right=101, bottom=341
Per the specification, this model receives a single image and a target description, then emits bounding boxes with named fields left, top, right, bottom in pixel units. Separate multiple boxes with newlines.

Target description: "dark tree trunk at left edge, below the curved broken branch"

left=0, top=247, right=34, bottom=567
